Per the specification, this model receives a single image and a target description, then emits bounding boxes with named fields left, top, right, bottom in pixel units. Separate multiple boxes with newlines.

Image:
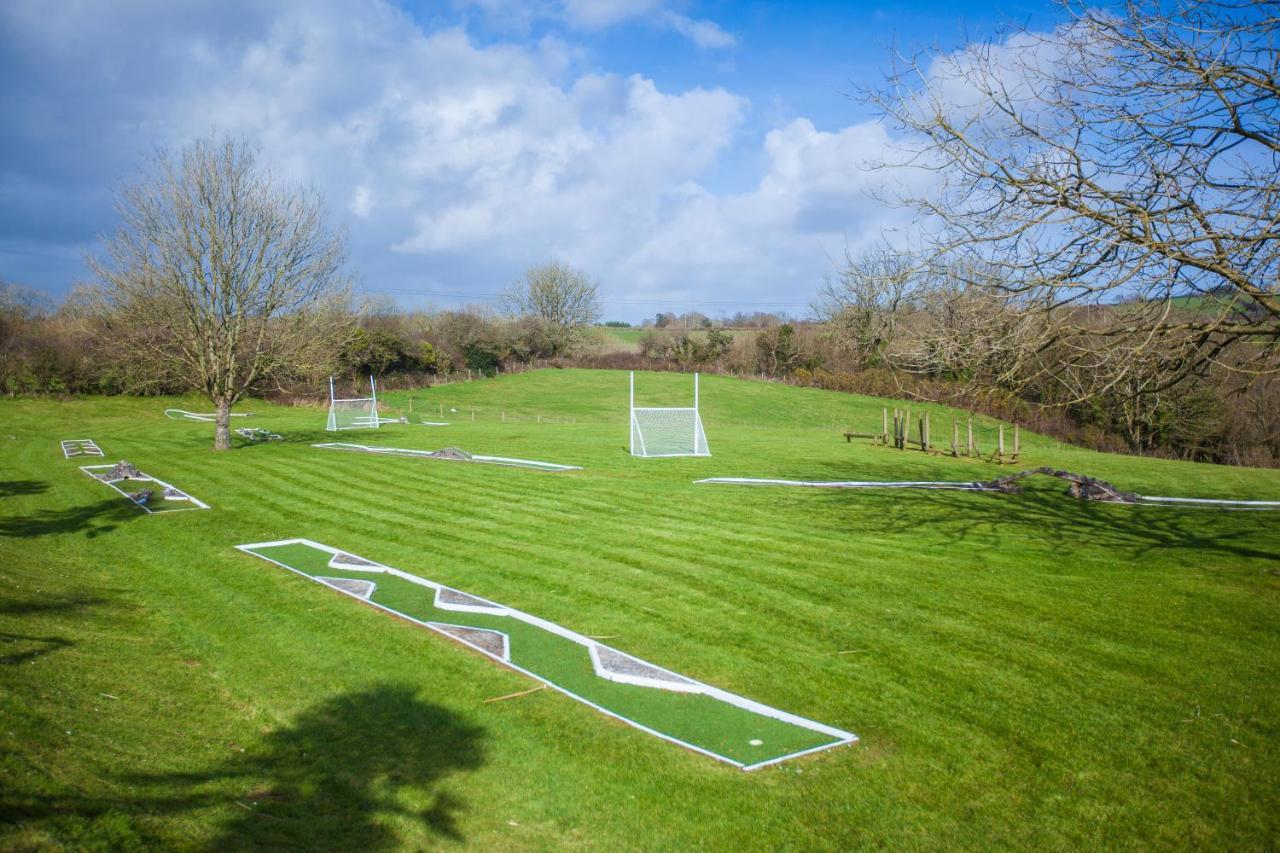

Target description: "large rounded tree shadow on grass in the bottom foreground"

left=0, top=684, right=485, bottom=850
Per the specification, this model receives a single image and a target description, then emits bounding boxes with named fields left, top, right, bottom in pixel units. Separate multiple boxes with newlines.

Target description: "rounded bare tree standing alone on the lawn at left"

left=91, top=138, right=351, bottom=450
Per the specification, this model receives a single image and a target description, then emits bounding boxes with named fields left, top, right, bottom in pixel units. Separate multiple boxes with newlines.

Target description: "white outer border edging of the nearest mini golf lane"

left=236, top=538, right=858, bottom=770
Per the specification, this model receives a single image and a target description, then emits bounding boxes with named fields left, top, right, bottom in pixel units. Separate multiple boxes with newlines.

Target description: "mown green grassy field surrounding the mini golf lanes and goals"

left=0, top=370, right=1280, bottom=849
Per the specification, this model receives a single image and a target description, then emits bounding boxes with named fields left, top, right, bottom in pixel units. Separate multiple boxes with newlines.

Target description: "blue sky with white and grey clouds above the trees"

left=0, top=0, right=1061, bottom=321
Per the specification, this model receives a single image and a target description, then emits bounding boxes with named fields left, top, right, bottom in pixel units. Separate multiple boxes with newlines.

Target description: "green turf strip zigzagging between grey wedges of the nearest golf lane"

left=242, top=542, right=850, bottom=767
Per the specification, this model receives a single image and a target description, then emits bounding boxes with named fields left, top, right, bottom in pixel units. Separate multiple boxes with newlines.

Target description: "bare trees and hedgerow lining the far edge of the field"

left=0, top=0, right=1280, bottom=465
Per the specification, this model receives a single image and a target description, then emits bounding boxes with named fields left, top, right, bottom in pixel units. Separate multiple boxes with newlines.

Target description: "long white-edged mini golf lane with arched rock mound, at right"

left=694, top=466, right=1280, bottom=510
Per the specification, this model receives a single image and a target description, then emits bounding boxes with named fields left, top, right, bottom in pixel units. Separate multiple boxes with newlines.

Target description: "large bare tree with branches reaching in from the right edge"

left=873, top=0, right=1280, bottom=393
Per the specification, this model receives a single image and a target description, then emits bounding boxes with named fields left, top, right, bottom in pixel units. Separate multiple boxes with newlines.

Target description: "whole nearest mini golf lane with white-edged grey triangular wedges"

left=236, top=539, right=858, bottom=770
